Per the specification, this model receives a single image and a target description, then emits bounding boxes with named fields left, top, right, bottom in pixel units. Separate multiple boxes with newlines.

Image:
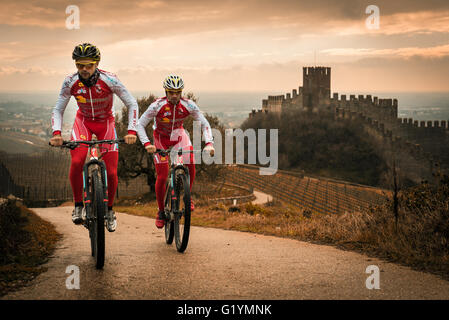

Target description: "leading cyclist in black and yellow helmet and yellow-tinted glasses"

left=50, top=43, right=139, bottom=232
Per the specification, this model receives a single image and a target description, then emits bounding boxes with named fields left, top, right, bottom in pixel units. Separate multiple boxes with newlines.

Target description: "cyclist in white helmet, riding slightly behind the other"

left=137, top=75, right=215, bottom=229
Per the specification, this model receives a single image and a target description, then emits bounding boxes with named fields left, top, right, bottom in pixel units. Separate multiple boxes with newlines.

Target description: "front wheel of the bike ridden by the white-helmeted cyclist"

left=174, top=173, right=190, bottom=252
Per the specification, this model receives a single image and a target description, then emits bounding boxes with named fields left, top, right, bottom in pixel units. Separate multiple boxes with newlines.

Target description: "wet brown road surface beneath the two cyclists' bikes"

left=3, top=207, right=449, bottom=299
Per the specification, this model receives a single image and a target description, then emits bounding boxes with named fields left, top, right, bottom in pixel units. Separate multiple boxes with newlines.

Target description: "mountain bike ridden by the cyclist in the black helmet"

left=51, top=139, right=125, bottom=269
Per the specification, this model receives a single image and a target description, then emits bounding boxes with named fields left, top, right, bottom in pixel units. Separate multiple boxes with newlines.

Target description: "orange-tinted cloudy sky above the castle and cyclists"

left=0, top=0, right=449, bottom=93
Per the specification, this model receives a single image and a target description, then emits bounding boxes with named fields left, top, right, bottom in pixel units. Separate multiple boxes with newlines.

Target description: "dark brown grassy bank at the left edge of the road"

left=0, top=201, right=61, bottom=296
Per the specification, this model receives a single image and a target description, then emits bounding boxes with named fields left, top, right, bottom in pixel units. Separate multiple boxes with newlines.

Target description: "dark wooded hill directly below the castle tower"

left=241, top=110, right=387, bottom=186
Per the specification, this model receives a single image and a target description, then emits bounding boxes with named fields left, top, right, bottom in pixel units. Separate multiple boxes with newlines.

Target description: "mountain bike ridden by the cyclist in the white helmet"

left=156, top=149, right=195, bottom=252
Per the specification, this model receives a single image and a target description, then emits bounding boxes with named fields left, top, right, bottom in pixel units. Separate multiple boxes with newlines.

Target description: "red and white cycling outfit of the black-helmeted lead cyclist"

left=51, top=70, right=139, bottom=206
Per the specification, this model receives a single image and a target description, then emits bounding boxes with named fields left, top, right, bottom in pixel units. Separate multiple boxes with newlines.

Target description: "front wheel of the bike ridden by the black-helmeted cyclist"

left=91, top=170, right=106, bottom=269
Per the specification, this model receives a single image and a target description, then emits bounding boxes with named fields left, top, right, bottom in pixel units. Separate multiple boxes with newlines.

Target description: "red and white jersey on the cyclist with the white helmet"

left=137, top=97, right=213, bottom=145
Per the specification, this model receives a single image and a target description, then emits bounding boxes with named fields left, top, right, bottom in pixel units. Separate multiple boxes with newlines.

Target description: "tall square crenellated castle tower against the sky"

left=302, top=67, right=331, bottom=110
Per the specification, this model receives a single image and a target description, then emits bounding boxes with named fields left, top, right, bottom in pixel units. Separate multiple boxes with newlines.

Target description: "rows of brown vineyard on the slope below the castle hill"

left=227, top=165, right=387, bottom=214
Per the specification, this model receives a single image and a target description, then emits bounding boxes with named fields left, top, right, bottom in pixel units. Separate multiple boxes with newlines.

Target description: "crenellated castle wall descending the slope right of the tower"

left=333, top=99, right=449, bottom=183
